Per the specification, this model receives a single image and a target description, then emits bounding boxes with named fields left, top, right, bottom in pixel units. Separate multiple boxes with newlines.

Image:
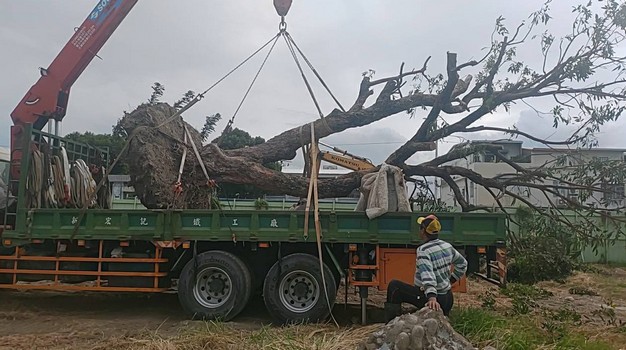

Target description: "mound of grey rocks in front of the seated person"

left=359, top=308, right=476, bottom=350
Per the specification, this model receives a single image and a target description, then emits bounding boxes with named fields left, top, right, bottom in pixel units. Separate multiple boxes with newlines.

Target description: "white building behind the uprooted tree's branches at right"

left=441, top=141, right=626, bottom=207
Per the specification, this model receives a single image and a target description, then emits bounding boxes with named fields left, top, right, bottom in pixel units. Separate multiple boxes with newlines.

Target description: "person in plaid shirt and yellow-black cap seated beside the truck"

left=385, top=215, right=467, bottom=322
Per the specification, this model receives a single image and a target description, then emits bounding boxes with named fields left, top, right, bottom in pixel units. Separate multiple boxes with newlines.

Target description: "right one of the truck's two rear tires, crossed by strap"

left=263, top=253, right=337, bottom=324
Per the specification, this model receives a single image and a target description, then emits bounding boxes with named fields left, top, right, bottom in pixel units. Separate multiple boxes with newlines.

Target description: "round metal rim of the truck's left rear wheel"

left=193, top=267, right=233, bottom=309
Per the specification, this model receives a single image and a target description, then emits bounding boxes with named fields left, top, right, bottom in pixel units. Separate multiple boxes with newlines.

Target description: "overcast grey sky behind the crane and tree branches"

left=0, top=0, right=626, bottom=167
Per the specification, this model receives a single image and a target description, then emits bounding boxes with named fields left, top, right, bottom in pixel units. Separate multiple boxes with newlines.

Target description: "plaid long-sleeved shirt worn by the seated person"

left=415, top=239, right=467, bottom=297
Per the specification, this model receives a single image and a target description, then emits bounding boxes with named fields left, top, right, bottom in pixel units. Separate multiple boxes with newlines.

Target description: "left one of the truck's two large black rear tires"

left=178, top=250, right=252, bottom=321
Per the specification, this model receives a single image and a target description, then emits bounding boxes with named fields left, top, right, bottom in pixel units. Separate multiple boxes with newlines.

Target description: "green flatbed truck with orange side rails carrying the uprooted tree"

left=0, top=126, right=506, bottom=323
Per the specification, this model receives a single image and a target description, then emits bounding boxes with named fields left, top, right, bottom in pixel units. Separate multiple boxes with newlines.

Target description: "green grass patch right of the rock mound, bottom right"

left=450, top=308, right=614, bottom=350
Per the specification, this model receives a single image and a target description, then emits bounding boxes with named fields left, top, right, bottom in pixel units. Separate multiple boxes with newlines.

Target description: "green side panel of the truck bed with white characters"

left=2, top=209, right=505, bottom=246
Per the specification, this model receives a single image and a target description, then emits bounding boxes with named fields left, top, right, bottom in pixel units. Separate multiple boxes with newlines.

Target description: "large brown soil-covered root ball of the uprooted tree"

left=120, top=103, right=211, bottom=209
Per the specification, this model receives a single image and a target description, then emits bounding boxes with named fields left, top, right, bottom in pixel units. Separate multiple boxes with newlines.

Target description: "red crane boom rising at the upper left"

left=11, top=0, right=138, bottom=183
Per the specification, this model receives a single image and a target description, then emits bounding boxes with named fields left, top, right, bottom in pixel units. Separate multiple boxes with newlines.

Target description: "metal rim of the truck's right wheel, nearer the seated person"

left=279, top=271, right=320, bottom=313
